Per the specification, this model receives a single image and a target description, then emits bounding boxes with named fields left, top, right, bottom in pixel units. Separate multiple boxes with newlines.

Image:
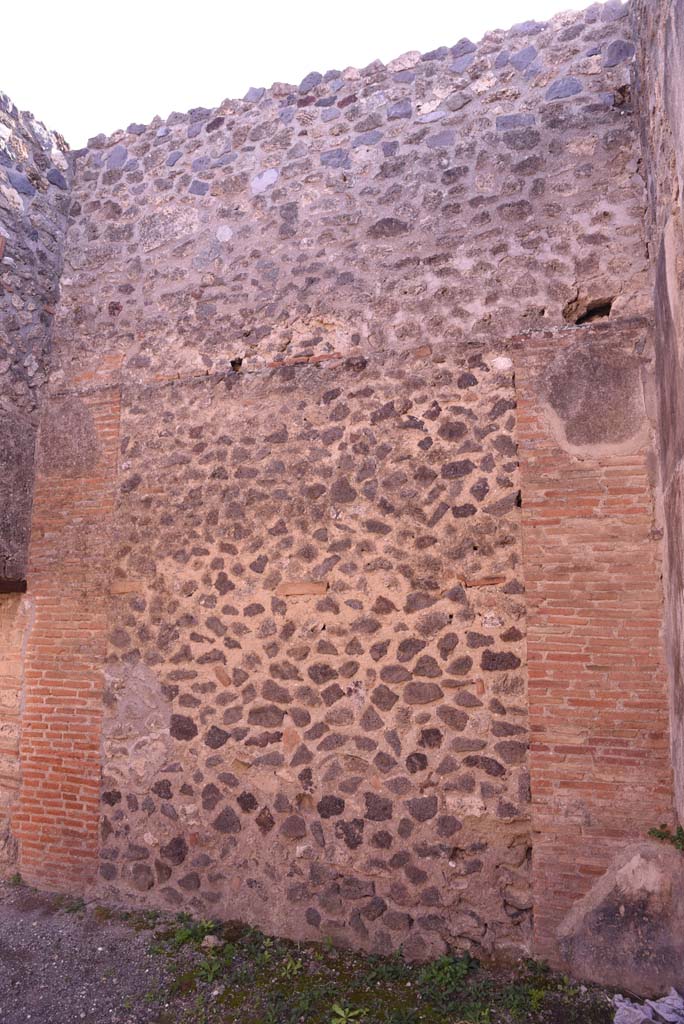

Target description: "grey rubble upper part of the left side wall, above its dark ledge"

left=0, top=93, right=70, bottom=580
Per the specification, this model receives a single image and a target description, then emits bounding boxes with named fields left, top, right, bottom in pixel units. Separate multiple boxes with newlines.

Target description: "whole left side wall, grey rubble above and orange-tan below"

left=0, top=93, right=69, bottom=864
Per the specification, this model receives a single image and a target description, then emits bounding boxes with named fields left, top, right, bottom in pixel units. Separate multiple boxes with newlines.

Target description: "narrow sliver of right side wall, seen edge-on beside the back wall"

left=633, top=0, right=684, bottom=820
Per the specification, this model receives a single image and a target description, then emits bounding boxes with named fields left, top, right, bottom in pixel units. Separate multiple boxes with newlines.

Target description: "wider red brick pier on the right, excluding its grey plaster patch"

left=516, top=330, right=672, bottom=964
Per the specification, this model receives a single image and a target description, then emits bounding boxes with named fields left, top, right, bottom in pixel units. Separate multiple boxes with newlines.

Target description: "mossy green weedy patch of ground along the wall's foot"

left=140, top=914, right=611, bottom=1024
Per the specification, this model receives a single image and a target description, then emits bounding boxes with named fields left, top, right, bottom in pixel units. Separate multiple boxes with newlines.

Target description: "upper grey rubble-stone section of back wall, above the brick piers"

left=54, top=3, right=649, bottom=388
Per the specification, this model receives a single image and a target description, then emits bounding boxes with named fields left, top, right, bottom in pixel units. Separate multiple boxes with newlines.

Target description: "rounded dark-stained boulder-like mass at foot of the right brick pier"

left=558, top=841, right=684, bottom=996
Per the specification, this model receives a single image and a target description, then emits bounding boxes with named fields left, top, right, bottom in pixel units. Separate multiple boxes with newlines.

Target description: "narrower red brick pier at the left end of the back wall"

left=12, top=387, right=120, bottom=889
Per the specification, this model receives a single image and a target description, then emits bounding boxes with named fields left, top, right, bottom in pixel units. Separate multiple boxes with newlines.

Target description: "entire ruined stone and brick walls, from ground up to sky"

left=0, top=0, right=684, bottom=991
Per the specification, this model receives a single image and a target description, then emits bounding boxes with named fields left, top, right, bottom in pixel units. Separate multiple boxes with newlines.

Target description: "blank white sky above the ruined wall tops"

left=0, top=0, right=589, bottom=148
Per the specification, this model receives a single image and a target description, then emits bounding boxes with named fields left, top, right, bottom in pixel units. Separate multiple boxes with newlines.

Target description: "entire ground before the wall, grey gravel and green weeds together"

left=0, top=879, right=613, bottom=1024
